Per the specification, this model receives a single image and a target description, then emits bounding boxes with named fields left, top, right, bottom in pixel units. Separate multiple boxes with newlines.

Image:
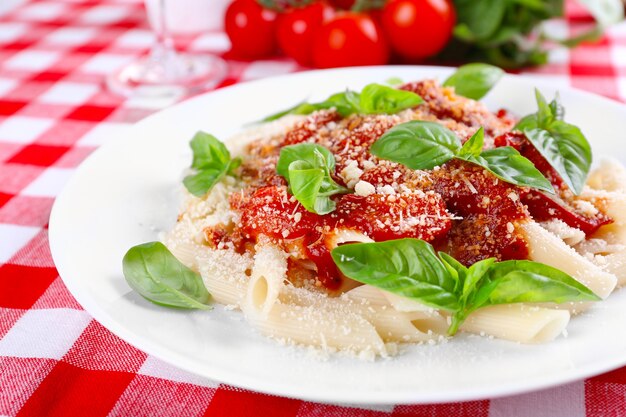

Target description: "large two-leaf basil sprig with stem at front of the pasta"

left=331, top=239, right=600, bottom=335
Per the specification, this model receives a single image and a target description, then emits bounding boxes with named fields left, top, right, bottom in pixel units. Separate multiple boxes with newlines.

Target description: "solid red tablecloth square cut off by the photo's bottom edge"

left=17, top=361, right=135, bottom=417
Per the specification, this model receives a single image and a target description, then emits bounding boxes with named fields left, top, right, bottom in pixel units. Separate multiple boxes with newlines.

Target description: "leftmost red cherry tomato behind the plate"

left=224, top=0, right=276, bottom=58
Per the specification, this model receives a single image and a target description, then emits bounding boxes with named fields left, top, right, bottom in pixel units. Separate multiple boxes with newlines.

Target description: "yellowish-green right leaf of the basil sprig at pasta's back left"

left=359, top=84, right=424, bottom=114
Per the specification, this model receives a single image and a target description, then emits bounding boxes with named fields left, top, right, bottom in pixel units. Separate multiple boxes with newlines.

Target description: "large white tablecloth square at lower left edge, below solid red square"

left=0, top=308, right=91, bottom=360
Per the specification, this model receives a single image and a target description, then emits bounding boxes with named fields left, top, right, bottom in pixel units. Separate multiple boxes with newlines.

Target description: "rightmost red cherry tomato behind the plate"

left=381, top=0, right=456, bottom=61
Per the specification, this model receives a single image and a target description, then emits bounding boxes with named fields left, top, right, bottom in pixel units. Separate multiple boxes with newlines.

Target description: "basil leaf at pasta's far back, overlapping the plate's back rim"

left=443, top=64, right=504, bottom=100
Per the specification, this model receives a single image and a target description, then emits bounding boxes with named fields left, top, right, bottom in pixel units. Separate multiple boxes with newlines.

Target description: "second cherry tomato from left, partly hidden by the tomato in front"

left=276, top=2, right=333, bottom=66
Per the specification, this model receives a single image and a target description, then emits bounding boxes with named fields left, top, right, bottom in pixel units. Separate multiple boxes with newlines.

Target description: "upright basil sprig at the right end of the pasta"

left=515, top=90, right=593, bottom=194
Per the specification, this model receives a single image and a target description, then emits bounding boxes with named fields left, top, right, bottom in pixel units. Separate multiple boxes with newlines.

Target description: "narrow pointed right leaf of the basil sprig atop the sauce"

left=458, top=146, right=554, bottom=194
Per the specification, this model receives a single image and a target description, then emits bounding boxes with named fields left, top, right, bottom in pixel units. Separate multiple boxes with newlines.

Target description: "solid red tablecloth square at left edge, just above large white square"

left=0, top=264, right=59, bottom=309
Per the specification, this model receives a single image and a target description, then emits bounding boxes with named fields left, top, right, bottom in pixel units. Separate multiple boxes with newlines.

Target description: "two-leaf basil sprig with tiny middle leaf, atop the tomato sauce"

left=370, top=120, right=554, bottom=193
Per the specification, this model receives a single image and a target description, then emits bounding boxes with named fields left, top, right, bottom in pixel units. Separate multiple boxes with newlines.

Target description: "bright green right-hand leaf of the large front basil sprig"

left=472, top=261, right=600, bottom=310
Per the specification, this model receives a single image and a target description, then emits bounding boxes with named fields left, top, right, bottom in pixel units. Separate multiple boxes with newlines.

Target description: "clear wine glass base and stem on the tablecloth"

left=106, top=0, right=227, bottom=98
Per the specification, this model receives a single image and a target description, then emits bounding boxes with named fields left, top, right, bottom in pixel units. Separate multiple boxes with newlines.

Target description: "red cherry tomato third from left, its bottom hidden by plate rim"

left=313, top=12, right=389, bottom=68
